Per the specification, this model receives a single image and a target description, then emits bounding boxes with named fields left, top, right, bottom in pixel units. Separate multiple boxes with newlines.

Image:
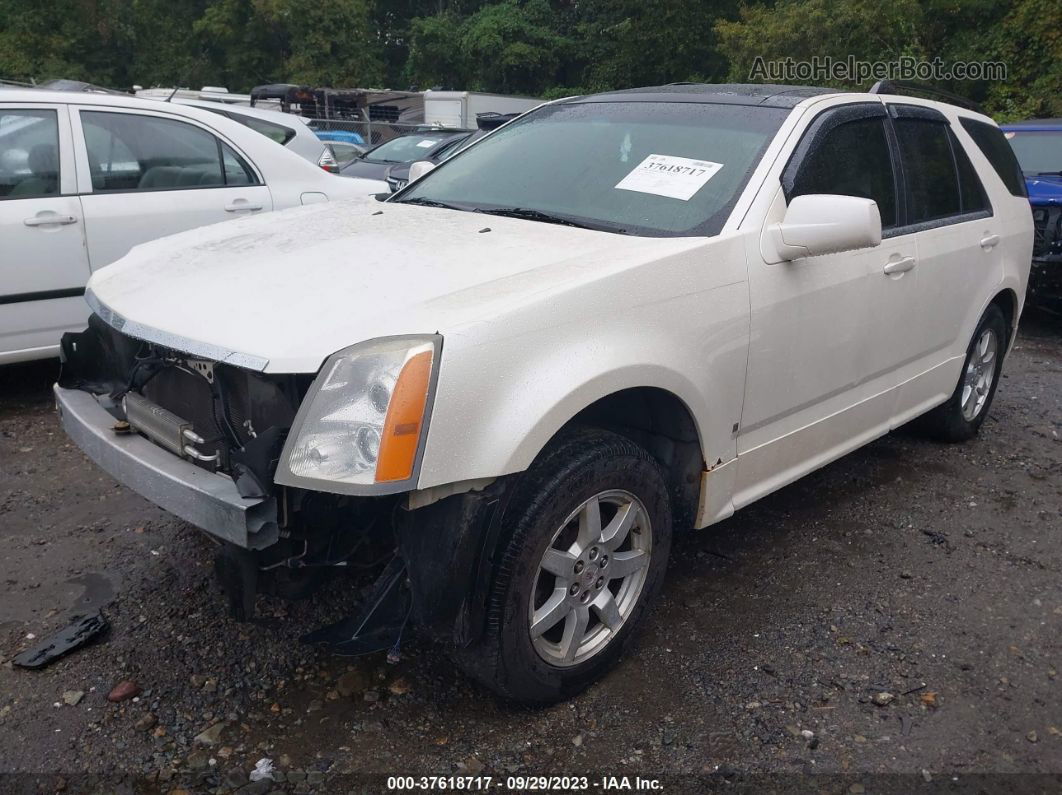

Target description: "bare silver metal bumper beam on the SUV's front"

left=54, top=384, right=279, bottom=550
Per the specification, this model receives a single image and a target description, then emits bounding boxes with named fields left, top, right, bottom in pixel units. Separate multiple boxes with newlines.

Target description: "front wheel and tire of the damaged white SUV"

left=456, top=430, right=671, bottom=705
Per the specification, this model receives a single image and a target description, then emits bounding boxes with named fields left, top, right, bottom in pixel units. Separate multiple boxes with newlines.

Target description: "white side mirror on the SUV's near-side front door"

left=772, top=193, right=881, bottom=260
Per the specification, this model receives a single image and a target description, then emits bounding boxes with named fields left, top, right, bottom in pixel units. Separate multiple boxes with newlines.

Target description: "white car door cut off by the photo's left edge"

left=0, top=102, right=89, bottom=363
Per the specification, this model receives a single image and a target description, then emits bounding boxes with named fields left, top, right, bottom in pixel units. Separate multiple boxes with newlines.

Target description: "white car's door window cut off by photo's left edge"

left=0, top=109, right=59, bottom=198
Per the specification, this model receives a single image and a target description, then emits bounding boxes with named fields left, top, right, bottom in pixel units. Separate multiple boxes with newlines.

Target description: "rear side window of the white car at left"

left=81, top=110, right=257, bottom=192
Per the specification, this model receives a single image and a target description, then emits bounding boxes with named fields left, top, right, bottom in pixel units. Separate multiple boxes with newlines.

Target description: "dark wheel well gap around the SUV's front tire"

left=568, top=386, right=705, bottom=530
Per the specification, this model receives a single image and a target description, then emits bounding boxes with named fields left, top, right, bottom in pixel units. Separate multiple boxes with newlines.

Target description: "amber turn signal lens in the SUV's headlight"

left=376, top=350, right=432, bottom=483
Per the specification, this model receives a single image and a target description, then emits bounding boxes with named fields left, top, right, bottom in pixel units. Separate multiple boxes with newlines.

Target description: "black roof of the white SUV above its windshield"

left=567, top=83, right=845, bottom=107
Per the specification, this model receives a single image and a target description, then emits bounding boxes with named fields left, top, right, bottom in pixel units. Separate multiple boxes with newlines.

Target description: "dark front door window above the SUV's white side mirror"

left=789, top=119, right=896, bottom=228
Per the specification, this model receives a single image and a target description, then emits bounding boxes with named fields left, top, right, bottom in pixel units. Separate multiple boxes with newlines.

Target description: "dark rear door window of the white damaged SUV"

left=895, top=119, right=962, bottom=224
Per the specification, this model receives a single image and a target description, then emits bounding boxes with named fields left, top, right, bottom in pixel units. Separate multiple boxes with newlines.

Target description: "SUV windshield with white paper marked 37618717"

left=394, top=102, right=789, bottom=237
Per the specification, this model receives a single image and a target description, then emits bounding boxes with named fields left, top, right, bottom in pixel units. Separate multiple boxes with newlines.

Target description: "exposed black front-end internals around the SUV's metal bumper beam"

left=58, top=315, right=498, bottom=655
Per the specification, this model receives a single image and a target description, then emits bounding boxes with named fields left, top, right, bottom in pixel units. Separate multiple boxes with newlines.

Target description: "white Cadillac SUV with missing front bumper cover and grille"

left=55, top=85, right=1032, bottom=703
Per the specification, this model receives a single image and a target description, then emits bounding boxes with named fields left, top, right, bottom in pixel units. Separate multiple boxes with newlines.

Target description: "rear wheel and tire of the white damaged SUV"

left=922, top=304, right=1007, bottom=442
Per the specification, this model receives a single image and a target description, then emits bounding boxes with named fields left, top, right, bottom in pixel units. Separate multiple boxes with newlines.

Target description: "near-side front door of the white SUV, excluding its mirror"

left=734, top=103, right=900, bottom=507
